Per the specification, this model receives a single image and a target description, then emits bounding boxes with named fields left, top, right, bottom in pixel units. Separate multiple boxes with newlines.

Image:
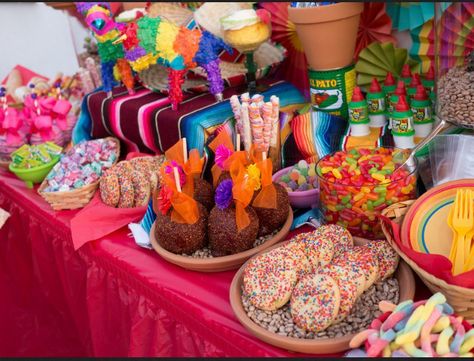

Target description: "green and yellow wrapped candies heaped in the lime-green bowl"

left=11, top=142, right=63, bottom=169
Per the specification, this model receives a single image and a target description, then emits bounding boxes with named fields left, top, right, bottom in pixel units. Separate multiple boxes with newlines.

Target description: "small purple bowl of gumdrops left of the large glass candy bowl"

left=273, top=160, right=319, bottom=208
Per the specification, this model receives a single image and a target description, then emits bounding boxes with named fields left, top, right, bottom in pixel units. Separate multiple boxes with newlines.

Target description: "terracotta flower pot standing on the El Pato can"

left=288, top=2, right=364, bottom=70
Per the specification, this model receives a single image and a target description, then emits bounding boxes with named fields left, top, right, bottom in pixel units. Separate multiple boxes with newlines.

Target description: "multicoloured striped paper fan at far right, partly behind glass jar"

left=410, top=2, right=474, bottom=72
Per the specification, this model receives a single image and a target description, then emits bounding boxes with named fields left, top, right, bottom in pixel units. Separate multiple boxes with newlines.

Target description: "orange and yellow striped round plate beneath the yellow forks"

left=401, top=179, right=474, bottom=257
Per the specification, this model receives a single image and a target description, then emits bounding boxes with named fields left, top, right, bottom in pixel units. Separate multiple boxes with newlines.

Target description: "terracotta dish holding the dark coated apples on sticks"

left=150, top=208, right=293, bottom=272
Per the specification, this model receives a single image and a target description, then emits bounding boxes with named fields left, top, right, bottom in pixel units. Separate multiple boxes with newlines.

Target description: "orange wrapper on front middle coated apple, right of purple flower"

left=230, top=159, right=255, bottom=232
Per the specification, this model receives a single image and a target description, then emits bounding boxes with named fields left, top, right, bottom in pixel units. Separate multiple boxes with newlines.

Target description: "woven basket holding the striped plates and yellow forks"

left=382, top=200, right=474, bottom=323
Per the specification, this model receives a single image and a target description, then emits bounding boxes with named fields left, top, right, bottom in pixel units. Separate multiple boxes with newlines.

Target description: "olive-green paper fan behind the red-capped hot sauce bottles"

left=355, top=42, right=419, bottom=87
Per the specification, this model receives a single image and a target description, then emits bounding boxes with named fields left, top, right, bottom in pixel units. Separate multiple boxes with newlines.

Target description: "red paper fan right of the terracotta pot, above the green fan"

left=354, top=2, right=396, bottom=60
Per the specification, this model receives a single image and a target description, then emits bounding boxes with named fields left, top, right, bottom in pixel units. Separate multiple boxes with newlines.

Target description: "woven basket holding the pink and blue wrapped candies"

left=38, top=137, right=120, bottom=211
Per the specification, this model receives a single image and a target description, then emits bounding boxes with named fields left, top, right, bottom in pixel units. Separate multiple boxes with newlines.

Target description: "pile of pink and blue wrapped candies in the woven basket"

left=44, top=139, right=118, bottom=192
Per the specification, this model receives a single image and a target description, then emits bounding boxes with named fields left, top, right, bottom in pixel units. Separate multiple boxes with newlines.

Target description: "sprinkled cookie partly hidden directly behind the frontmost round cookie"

left=319, top=265, right=358, bottom=324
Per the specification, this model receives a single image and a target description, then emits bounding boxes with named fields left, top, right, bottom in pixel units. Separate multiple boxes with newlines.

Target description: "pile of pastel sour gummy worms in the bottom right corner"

left=347, top=292, right=474, bottom=357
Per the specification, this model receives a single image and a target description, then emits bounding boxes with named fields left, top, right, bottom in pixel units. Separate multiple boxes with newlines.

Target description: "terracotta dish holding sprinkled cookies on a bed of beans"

left=229, top=237, right=415, bottom=354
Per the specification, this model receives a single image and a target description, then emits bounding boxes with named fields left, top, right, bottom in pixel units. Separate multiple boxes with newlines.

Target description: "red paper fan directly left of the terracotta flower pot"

left=258, top=2, right=309, bottom=99
